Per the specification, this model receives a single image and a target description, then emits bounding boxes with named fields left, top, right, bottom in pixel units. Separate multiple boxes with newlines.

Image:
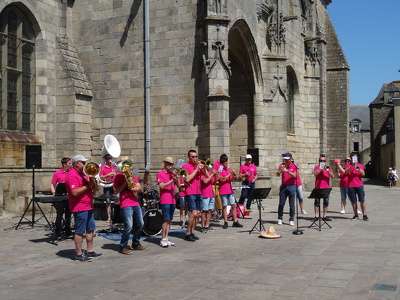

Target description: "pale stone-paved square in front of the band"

left=0, top=179, right=400, bottom=300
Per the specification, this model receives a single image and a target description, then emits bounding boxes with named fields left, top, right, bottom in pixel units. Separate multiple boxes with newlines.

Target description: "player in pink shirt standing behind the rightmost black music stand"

left=312, top=154, right=333, bottom=222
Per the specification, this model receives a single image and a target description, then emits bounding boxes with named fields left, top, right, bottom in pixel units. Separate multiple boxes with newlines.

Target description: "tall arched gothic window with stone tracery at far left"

left=0, top=6, right=35, bottom=132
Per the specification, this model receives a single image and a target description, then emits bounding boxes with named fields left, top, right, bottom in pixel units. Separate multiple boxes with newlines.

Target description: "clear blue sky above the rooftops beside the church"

left=328, top=0, right=400, bottom=105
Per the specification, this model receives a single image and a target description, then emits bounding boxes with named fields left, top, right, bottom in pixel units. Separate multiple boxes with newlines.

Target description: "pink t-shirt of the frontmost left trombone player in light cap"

left=65, top=168, right=93, bottom=212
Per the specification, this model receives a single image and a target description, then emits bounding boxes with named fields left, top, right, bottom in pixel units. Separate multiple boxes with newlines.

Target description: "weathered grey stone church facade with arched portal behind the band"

left=0, top=0, right=349, bottom=211
